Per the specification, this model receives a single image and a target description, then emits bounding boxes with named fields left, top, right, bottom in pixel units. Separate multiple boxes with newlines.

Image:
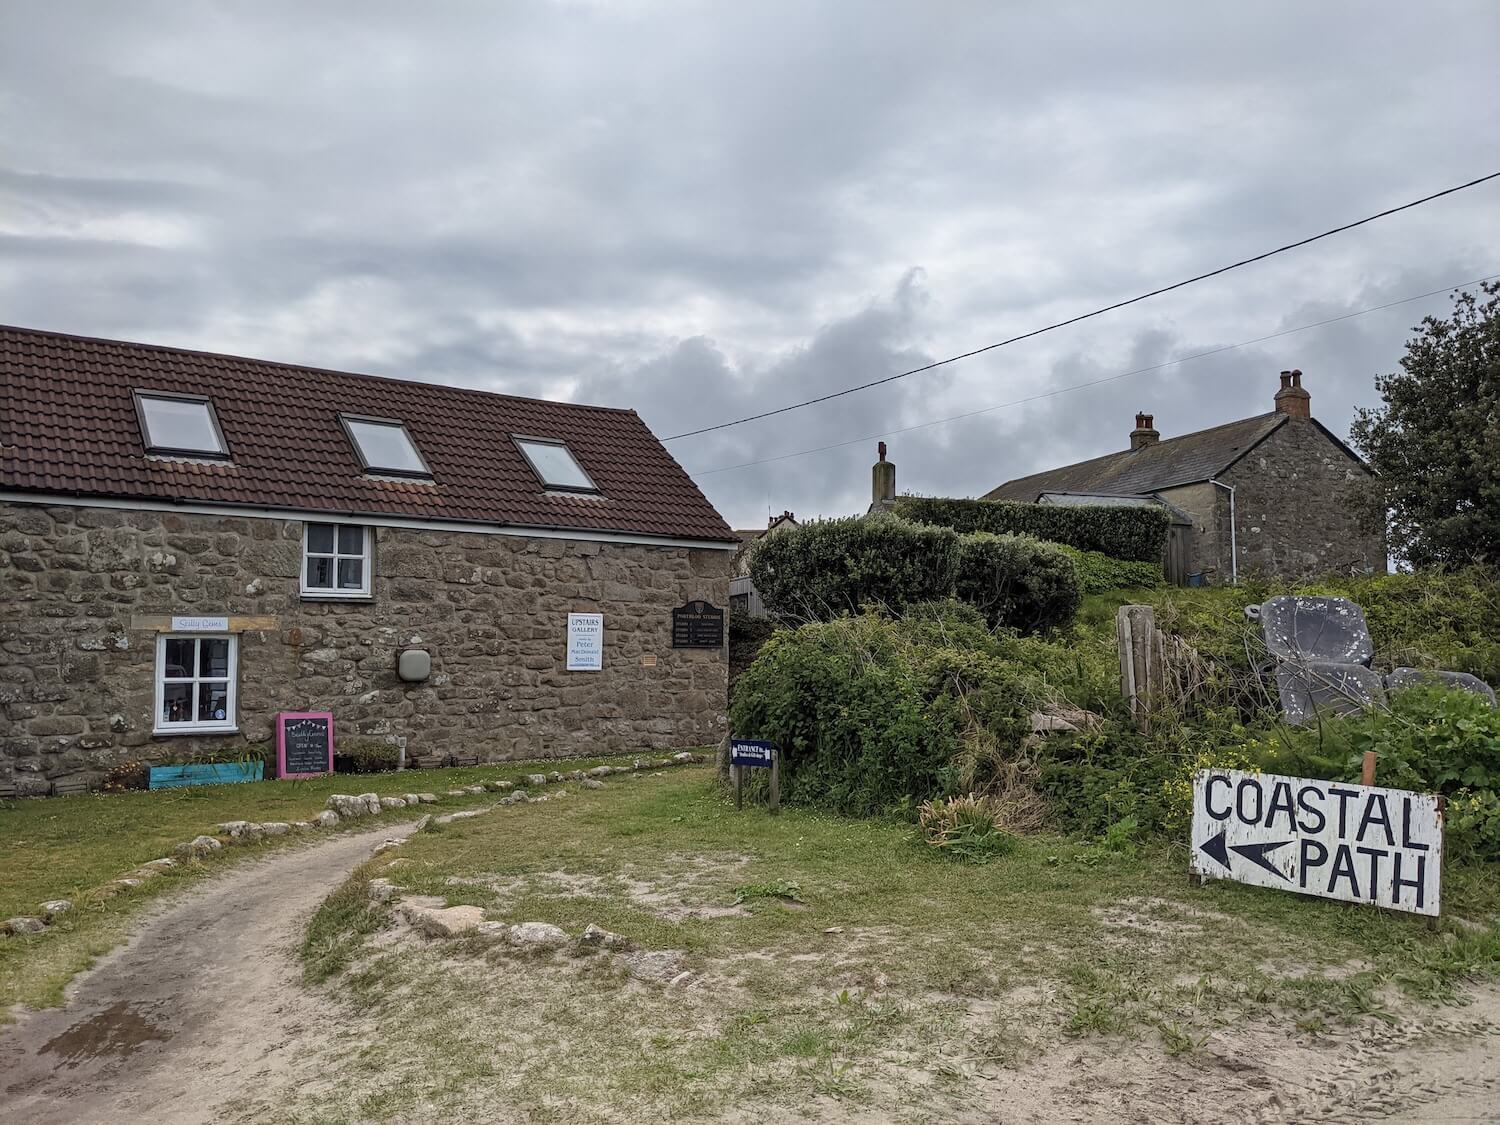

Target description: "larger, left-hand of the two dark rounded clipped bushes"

left=750, top=516, right=959, bottom=621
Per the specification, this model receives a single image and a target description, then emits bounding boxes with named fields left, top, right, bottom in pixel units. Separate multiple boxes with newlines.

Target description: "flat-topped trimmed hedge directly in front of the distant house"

left=894, top=497, right=1172, bottom=564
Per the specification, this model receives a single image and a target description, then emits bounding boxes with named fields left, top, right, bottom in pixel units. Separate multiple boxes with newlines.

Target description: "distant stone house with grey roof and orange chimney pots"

left=984, top=371, right=1386, bottom=582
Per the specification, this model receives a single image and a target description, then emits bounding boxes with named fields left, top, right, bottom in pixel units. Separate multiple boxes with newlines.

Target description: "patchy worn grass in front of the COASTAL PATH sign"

left=258, top=770, right=1500, bottom=1121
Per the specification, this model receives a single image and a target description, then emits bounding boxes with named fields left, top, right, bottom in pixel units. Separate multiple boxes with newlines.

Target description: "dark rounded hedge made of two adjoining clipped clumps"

left=750, top=516, right=1082, bottom=632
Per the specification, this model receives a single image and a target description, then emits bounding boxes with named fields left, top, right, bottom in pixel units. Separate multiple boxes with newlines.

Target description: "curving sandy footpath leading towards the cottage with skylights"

left=0, top=824, right=401, bottom=1125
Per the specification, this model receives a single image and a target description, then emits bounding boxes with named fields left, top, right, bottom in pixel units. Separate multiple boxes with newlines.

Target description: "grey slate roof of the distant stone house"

left=984, top=411, right=1290, bottom=504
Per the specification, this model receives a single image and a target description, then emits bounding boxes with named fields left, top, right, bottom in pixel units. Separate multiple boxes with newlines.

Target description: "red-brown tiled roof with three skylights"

left=0, top=327, right=738, bottom=543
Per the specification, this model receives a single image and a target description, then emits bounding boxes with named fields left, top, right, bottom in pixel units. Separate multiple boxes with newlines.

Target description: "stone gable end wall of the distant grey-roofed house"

left=1218, top=419, right=1386, bottom=581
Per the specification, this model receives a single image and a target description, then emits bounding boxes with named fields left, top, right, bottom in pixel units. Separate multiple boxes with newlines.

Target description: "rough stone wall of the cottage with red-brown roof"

left=0, top=504, right=734, bottom=794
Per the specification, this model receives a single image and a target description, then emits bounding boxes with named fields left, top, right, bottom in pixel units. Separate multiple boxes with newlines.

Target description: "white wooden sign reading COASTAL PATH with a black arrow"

left=1190, top=770, right=1443, bottom=917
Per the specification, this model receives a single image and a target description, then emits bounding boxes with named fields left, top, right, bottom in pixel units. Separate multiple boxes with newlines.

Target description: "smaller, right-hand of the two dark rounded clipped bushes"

left=954, top=531, right=1083, bottom=633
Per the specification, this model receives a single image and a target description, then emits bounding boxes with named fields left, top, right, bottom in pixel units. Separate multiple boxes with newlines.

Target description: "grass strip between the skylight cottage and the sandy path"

left=0, top=758, right=654, bottom=1019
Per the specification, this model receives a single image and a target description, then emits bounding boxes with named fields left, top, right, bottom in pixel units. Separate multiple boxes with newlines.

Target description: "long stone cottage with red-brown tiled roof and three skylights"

left=0, top=329, right=740, bottom=794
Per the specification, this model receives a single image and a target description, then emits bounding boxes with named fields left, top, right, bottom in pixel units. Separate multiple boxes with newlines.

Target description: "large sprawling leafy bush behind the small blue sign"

left=729, top=609, right=1046, bottom=816
